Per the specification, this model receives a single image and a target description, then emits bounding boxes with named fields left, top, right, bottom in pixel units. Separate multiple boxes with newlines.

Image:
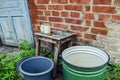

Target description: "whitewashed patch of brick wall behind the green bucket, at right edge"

left=92, top=22, right=120, bottom=63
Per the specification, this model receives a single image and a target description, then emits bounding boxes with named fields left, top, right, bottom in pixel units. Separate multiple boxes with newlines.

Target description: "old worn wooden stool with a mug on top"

left=35, top=30, right=75, bottom=78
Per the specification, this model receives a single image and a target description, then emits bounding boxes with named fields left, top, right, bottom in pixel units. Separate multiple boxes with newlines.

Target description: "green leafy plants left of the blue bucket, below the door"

left=0, top=41, right=35, bottom=80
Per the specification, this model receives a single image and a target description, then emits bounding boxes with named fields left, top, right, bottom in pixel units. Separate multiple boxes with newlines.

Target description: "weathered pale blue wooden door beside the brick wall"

left=0, top=0, right=34, bottom=45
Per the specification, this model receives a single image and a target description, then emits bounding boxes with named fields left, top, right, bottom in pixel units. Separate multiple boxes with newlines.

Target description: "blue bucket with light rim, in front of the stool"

left=18, top=56, right=54, bottom=80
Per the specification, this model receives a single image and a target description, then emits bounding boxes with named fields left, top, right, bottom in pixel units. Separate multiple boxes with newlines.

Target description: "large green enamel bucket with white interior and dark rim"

left=62, top=46, right=109, bottom=80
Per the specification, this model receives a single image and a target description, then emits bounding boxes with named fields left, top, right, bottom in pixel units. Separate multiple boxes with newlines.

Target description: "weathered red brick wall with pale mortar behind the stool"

left=29, top=0, right=120, bottom=61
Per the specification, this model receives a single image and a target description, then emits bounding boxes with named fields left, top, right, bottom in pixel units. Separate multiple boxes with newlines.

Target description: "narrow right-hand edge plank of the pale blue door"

left=18, top=0, right=34, bottom=44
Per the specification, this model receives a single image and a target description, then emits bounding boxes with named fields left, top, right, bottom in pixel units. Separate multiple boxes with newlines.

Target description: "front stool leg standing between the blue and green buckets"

left=53, top=42, right=60, bottom=79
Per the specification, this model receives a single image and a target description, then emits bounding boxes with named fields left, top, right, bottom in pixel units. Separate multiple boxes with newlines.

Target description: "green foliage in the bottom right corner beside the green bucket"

left=105, top=63, right=120, bottom=80
